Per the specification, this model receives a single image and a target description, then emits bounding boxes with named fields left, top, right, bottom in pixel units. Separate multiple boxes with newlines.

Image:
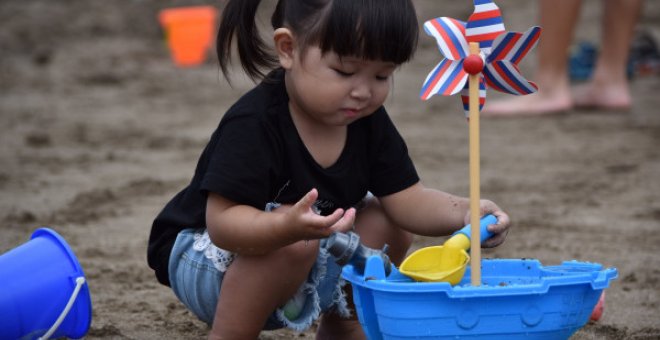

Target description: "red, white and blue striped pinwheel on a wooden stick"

left=421, top=0, right=541, bottom=286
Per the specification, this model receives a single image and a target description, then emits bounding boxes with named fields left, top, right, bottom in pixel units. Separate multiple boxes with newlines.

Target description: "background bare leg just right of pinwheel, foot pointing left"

left=483, top=0, right=581, bottom=116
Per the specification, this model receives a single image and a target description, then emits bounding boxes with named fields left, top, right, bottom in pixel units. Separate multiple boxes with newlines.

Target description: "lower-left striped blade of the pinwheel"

left=420, top=59, right=467, bottom=100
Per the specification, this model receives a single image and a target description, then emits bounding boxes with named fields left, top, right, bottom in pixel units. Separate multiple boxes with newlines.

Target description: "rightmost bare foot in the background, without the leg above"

left=573, top=82, right=632, bottom=111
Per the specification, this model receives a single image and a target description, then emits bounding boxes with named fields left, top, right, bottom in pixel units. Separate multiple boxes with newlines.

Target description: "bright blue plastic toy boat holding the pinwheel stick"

left=342, top=257, right=617, bottom=340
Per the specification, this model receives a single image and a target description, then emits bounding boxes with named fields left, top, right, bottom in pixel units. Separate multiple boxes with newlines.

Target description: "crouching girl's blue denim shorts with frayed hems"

left=169, top=229, right=350, bottom=331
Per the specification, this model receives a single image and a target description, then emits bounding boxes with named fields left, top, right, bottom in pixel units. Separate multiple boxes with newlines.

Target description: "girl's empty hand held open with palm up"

left=284, top=189, right=355, bottom=240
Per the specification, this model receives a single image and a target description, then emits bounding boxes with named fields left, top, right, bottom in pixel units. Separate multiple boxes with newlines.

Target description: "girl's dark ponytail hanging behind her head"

left=216, top=0, right=279, bottom=79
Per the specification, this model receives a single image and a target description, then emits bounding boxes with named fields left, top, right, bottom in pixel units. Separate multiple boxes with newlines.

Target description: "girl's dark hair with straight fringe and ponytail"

left=217, top=0, right=419, bottom=79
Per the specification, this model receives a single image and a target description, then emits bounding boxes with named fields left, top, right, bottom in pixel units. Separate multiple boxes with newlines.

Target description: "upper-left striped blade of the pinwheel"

left=424, top=17, right=468, bottom=60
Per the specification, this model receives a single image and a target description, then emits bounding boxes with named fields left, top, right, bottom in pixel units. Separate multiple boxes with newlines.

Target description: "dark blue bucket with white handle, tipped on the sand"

left=0, top=228, right=92, bottom=340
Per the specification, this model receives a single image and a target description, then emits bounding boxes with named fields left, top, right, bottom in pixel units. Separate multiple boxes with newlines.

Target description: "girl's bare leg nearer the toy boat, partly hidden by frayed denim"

left=316, top=198, right=413, bottom=340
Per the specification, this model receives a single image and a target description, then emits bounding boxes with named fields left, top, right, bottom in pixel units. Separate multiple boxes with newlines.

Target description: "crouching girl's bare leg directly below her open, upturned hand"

left=209, top=240, right=319, bottom=340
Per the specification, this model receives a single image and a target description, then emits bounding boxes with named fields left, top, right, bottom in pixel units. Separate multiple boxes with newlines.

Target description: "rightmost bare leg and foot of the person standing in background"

left=574, top=0, right=642, bottom=109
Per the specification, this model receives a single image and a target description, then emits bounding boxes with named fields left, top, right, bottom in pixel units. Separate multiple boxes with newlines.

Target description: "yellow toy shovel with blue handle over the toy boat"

left=399, top=215, right=497, bottom=286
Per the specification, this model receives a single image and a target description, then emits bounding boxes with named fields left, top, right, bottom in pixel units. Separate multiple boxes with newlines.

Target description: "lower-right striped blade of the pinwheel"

left=483, top=60, right=538, bottom=95
